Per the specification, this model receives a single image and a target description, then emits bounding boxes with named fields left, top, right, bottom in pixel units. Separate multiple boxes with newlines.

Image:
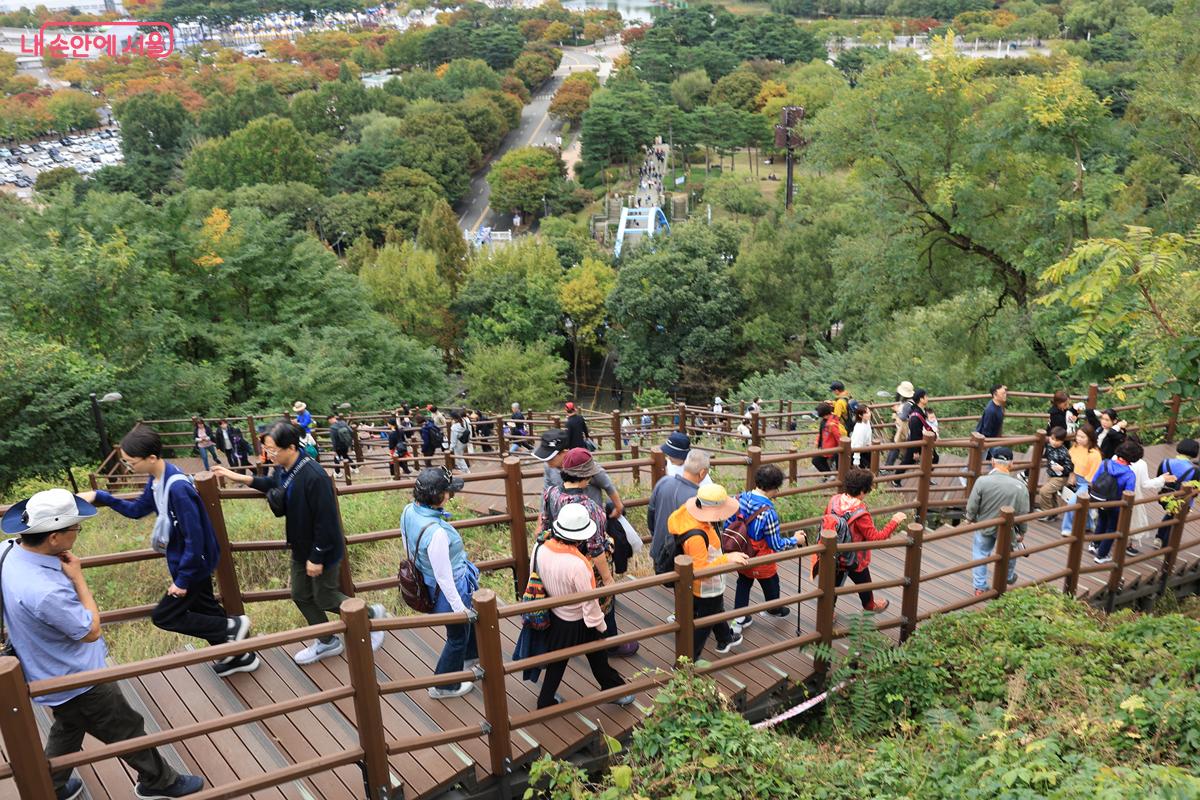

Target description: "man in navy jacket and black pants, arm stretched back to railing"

left=79, top=425, right=259, bottom=678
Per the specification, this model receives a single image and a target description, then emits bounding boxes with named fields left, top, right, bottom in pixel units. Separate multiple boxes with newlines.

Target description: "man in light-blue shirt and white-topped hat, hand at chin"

left=0, top=489, right=204, bottom=800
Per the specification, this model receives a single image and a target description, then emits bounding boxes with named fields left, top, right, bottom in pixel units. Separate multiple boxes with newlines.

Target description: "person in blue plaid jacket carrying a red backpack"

left=733, top=464, right=800, bottom=628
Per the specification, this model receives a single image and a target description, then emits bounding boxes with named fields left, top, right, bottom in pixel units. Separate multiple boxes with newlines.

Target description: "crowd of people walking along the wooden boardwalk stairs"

left=0, top=381, right=1200, bottom=800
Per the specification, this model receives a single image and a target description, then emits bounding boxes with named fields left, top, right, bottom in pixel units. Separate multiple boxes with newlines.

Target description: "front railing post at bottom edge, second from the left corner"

left=341, top=597, right=391, bottom=800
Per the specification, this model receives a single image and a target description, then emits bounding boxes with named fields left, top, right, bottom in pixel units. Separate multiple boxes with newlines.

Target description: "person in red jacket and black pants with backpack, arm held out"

left=812, top=470, right=902, bottom=612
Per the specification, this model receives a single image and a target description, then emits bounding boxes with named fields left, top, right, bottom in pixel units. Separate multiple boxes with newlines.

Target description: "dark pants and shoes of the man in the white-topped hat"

left=46, top=684, right=179, bottom=790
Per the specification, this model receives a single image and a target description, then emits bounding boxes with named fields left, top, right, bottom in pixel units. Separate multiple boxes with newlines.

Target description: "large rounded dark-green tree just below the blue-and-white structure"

left=608, top=222, right=743, bottom=387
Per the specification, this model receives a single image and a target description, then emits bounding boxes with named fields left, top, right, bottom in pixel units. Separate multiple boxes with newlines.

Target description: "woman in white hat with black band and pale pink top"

left=533, top=503, right=636, bottom=709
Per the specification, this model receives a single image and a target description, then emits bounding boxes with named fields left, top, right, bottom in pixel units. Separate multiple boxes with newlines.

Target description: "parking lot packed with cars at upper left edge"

left=0, top=126, right=124, bottom=198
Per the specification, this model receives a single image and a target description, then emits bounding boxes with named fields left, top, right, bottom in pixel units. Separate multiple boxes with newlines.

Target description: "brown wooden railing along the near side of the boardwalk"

left=0, top=465, right=1200, bottom=800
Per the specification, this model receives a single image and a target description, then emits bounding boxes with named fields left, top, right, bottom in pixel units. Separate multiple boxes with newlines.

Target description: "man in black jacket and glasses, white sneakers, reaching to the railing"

left=214, top=422, right=388, bottom=664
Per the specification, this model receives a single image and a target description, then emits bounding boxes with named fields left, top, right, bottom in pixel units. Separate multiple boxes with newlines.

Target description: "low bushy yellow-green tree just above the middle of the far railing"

left=462, top=339, right=566, bottom=408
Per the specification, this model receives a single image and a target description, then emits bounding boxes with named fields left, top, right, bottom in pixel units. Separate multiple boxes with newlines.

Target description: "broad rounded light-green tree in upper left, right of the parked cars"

left=184, top=116, right=320, bottom=190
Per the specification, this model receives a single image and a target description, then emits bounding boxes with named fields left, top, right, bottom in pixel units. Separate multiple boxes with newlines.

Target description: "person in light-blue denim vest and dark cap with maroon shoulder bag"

left=400, top=467, right=479, bottom=700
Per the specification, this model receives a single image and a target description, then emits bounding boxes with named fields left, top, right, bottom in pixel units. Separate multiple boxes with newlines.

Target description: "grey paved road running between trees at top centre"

left=457, top=40, right=624, bottom=231
